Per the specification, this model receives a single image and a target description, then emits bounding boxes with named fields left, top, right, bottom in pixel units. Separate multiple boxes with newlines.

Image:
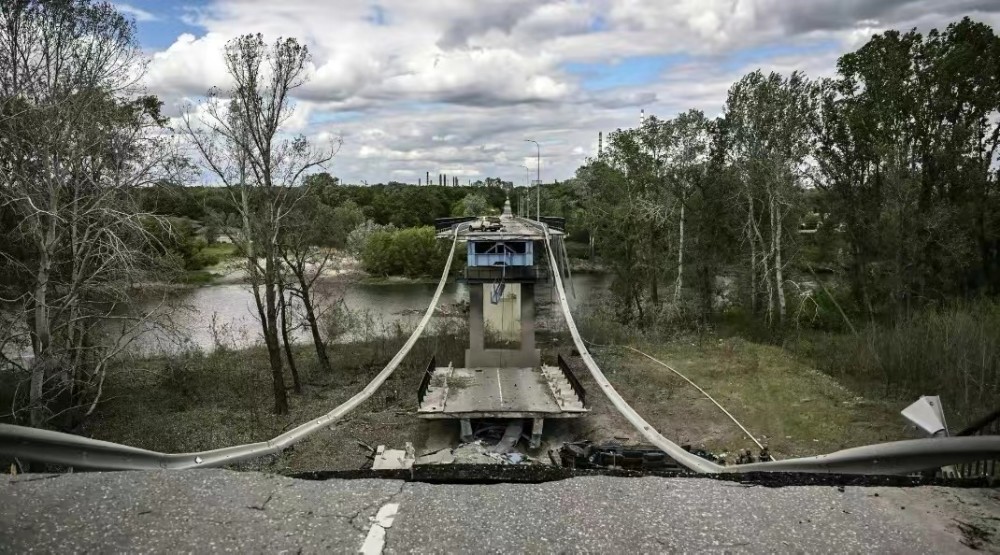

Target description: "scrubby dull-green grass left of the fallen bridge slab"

left=85, top=324, right=462, bottom=472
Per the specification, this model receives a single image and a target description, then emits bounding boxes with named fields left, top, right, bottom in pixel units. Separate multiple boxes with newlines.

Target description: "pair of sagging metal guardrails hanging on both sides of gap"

left=0, top=220, right=1000, bottom=474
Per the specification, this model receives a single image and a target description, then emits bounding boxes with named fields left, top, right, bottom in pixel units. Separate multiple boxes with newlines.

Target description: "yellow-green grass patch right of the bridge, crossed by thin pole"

left=584, top=338, right=904, bottom=457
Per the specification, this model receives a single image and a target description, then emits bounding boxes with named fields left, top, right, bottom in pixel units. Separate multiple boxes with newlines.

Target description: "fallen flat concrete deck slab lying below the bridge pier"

left=417, top=366, right=589, bottom=418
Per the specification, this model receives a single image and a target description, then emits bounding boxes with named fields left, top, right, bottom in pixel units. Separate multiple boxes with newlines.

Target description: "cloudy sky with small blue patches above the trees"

left=115, top=0, right=1000, bottom=187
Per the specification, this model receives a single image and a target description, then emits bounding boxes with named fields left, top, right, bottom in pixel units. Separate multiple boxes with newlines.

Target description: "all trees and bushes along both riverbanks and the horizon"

left=0, top=0, right=1000, bottom=444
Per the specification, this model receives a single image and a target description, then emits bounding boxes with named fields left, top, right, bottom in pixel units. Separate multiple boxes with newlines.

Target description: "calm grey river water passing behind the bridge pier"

left=133, top=274, right=610, bottom=354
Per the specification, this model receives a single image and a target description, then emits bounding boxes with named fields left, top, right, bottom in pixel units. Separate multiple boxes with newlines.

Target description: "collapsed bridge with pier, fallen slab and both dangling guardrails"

left=0, top=198, right=1000, bottom=474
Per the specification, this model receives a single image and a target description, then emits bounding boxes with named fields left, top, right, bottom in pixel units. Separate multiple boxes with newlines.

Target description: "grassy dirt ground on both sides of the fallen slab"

left=84, top=326, right=920, bottom=473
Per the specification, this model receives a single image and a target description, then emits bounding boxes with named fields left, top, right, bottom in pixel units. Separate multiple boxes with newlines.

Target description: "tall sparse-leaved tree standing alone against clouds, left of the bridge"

left=184, top=34, right=334, bottom=414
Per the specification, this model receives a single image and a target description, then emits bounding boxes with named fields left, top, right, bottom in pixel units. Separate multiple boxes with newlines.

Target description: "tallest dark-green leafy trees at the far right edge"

left=815, top=18, right=1000, bottom=319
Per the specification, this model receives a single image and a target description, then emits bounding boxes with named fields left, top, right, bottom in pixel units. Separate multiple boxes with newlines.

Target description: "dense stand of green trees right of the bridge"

left=576, top=19, right=1000, bottom=422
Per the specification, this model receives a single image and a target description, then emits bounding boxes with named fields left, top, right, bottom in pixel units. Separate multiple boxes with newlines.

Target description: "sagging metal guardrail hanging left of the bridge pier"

left=0, top=225, right=462, bottom=470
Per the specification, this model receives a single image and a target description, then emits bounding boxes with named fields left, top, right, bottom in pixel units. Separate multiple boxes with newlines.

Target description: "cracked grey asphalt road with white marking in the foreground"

left=0, top=470, right=1000, bottom=553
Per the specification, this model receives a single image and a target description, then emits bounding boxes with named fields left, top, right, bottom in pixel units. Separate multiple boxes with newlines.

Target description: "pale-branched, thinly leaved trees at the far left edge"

left=0, top=0, right=172, bottom=426
